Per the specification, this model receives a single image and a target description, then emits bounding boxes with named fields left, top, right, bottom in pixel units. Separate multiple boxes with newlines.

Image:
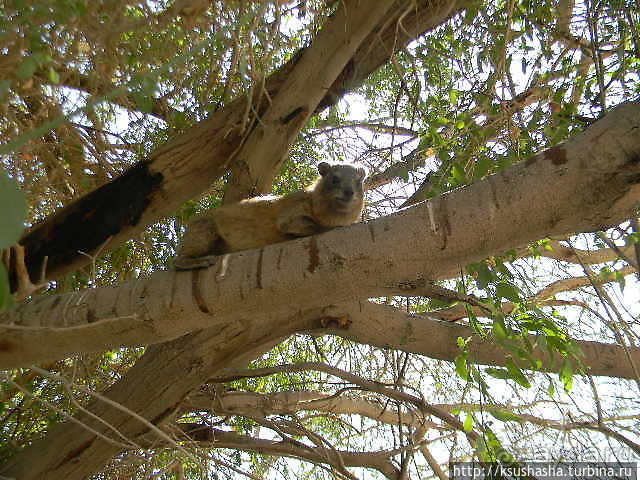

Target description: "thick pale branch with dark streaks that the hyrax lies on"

left=0, top=103, right=640, bottom=368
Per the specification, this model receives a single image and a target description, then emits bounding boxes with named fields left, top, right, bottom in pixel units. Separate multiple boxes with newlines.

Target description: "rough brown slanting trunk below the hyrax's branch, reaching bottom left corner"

left=0, top=320, right=304, bottom=480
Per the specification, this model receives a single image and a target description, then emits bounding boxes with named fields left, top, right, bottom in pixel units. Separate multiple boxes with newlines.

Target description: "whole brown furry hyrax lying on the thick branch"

left=173, top=162, right=365, bottom=270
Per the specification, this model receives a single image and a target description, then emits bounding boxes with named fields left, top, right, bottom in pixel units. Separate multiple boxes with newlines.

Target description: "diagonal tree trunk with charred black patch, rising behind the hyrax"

left=15, top=0, right=468, bottom=280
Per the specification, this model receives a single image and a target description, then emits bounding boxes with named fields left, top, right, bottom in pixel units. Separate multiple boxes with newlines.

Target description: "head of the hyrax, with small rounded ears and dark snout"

left=318, top=162, right=366, bottom=212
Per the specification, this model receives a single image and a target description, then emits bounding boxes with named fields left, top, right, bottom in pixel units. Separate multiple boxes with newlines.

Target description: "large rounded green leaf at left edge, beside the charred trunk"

left=0, top=170, right=27, bottom=249
